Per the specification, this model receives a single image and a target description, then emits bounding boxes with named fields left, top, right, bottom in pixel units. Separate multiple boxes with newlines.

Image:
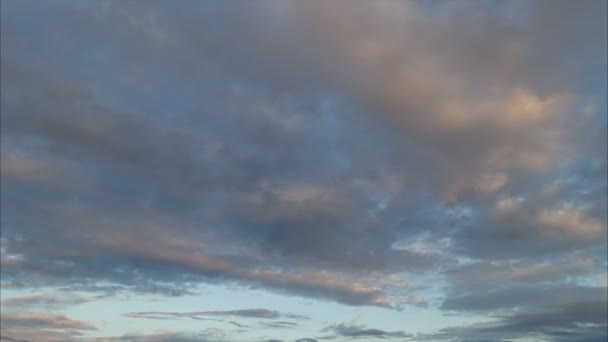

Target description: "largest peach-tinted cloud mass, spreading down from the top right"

left=134, top=2, right=604, bottom=200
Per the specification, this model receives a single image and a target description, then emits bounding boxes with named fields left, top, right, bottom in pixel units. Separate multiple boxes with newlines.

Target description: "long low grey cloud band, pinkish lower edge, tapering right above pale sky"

left=0, top=223, right=391, bottom=307
